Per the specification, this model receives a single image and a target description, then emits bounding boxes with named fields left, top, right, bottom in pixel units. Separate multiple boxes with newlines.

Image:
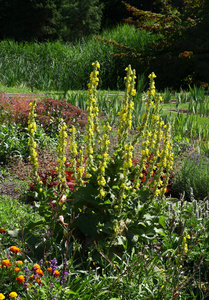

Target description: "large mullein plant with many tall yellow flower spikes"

left=29, top=62, right=175, bottom=254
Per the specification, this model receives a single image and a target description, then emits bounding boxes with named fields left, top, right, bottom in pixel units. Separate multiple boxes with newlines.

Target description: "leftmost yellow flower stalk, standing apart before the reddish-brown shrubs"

left=28, top=100, right=40, bottom=184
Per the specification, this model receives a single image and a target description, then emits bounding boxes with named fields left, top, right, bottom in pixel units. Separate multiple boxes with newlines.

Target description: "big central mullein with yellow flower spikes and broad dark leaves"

left=25, top=62, right=173, bottom=258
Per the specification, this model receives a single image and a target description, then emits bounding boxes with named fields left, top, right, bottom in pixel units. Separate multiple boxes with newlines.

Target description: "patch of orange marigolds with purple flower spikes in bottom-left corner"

left=0, top=246, right=69, bottom=299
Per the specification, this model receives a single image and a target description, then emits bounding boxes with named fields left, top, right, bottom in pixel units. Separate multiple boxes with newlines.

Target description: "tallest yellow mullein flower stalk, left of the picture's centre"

left=85, top=62, right=100, bottom=177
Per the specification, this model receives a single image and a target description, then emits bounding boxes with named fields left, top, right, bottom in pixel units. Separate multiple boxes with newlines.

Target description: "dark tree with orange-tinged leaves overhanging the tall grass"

left=98, top=0, right=209, bottom=88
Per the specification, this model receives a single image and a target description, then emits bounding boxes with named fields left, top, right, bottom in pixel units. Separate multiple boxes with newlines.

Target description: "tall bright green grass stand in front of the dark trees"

left=0, top=24, right=158, bottom=93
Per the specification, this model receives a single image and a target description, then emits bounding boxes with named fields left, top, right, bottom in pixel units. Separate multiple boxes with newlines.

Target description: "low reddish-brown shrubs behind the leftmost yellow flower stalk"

left=0, top=94, right=87, bottom=129
